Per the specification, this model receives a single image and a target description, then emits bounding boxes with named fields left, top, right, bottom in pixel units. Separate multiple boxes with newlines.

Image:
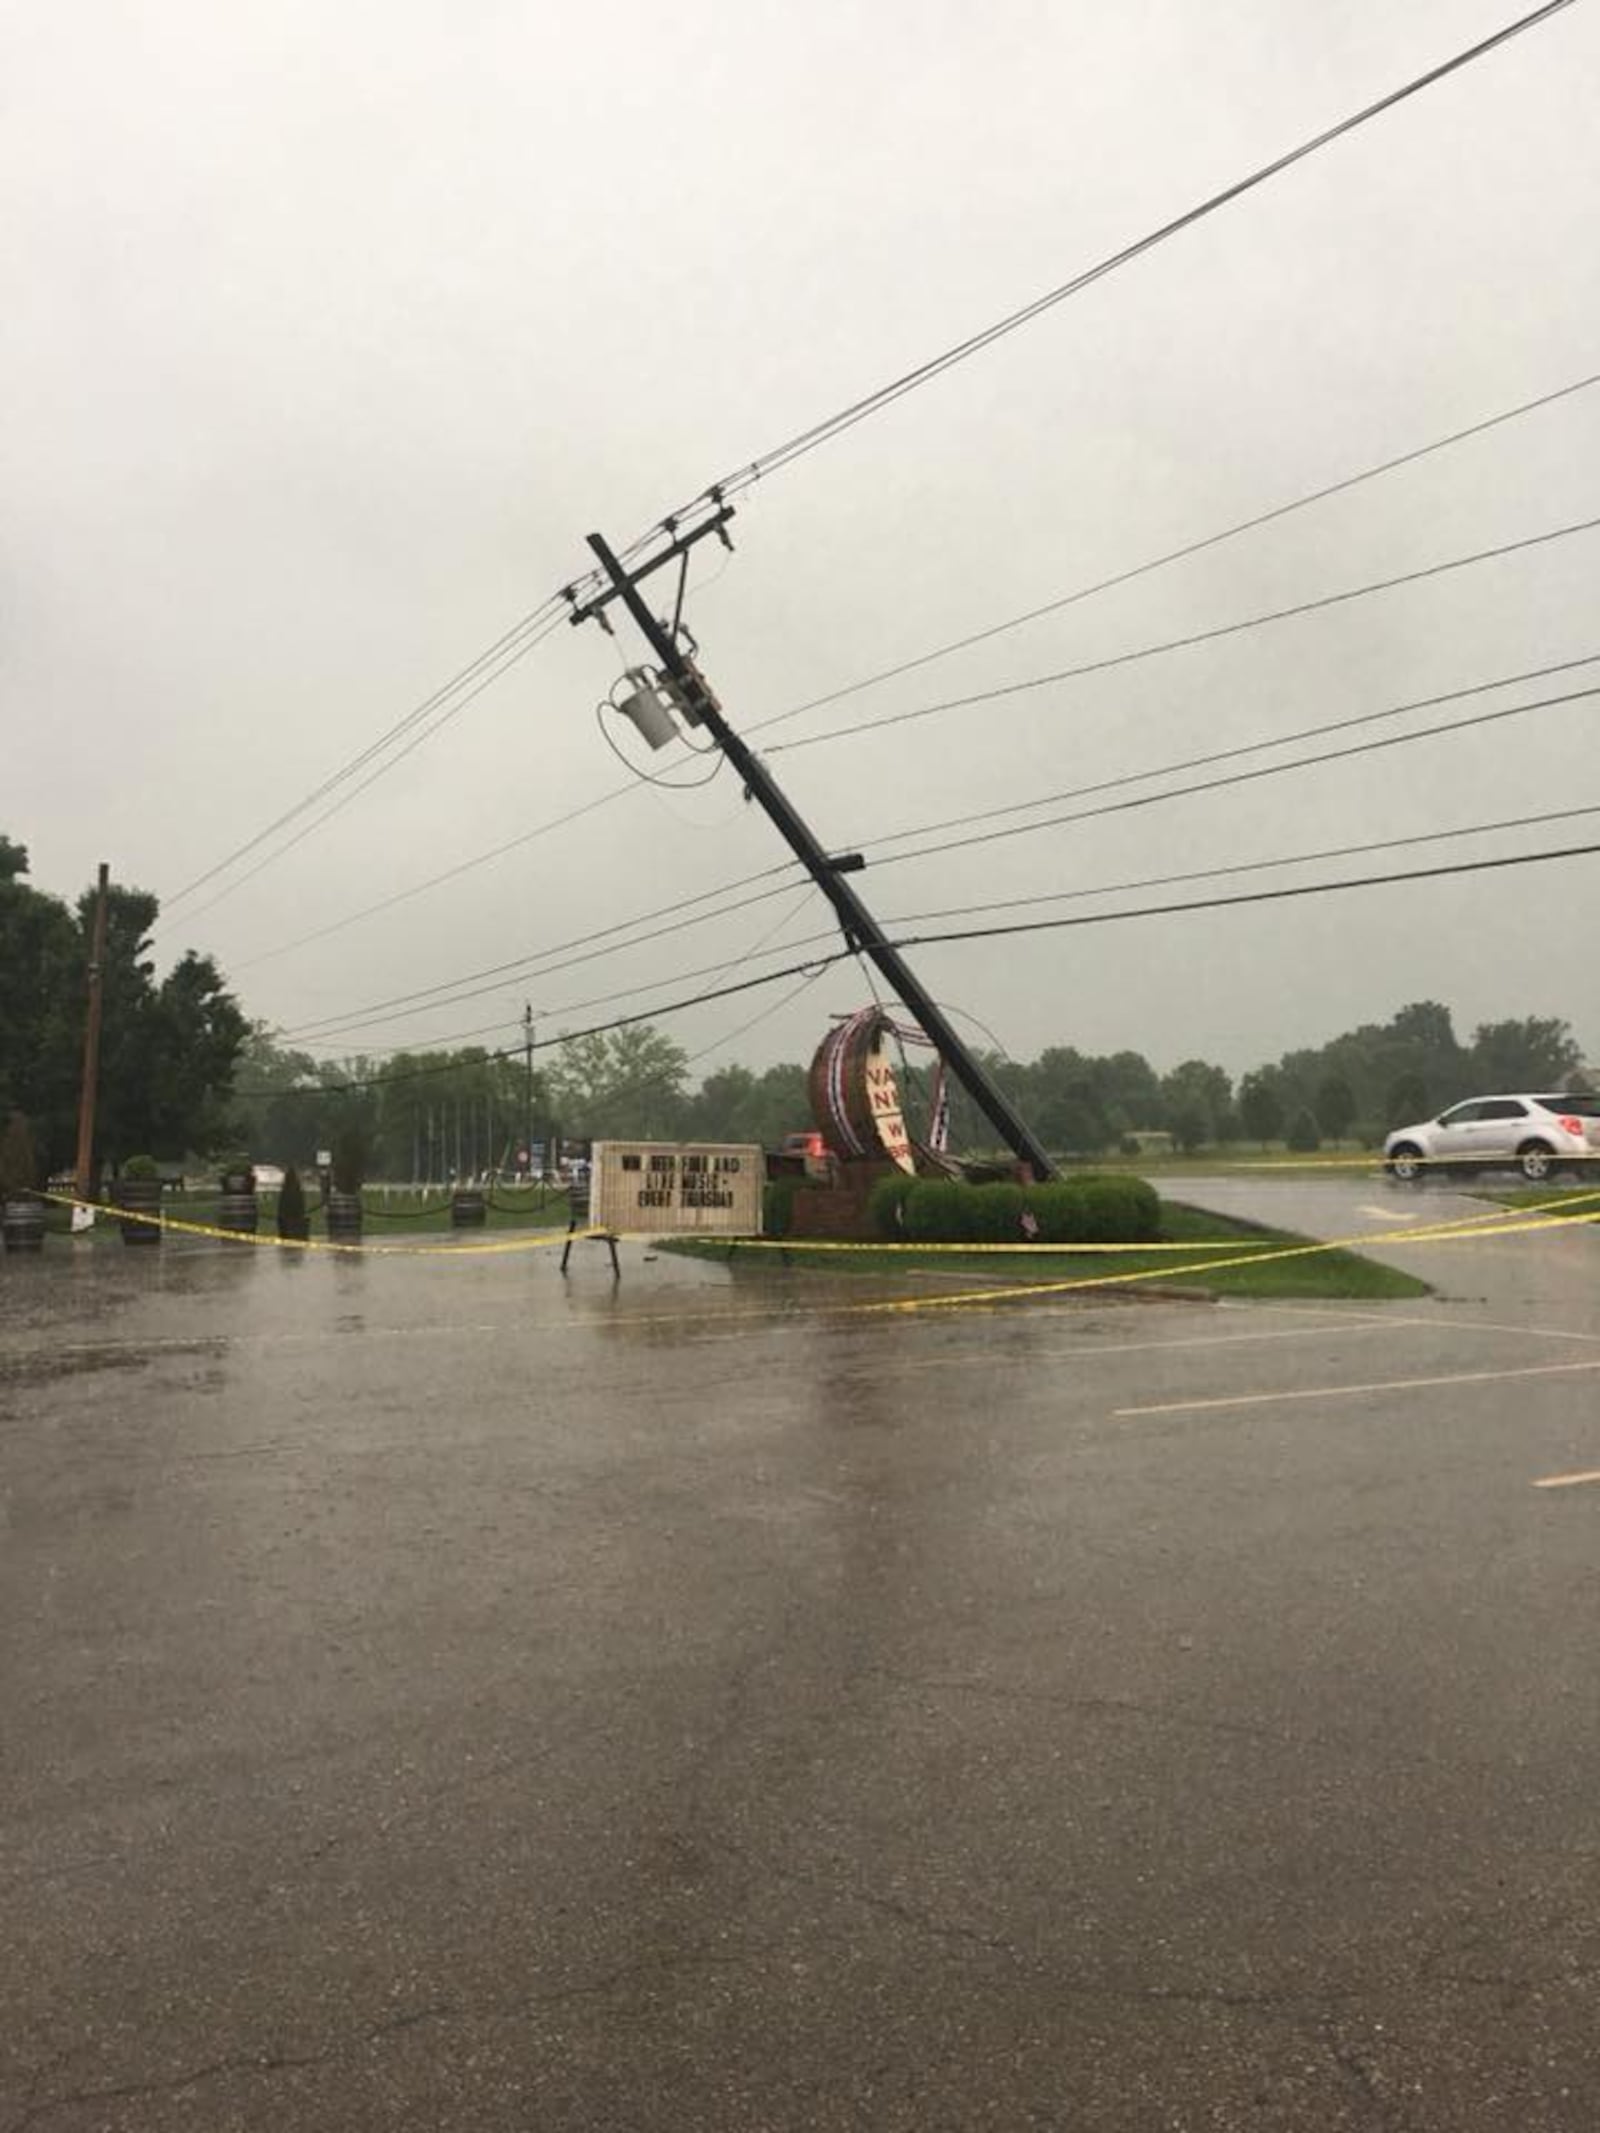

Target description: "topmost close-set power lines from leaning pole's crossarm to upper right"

left=627, top=0, right=1572, bottom=541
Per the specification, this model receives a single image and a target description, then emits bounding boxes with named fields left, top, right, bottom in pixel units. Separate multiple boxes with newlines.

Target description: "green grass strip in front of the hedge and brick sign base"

left=659, top=1201, right=1429, bottom=1301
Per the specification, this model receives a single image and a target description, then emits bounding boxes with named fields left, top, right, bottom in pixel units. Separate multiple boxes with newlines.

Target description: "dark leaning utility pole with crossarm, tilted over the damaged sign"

left=570, top=516, right=1056, bottom=1177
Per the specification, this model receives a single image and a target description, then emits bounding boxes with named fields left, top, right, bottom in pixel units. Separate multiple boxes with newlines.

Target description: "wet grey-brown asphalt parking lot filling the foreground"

left=0, top=1177, right=1600, bottom=2133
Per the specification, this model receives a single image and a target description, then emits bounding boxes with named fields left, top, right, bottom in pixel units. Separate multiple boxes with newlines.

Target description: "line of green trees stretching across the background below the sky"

left=0, top=836, right=1587, bottom=1180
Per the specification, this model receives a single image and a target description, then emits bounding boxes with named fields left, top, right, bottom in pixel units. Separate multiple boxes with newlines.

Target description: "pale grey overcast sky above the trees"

left=0, top=0, right=1600, bottom=1071
